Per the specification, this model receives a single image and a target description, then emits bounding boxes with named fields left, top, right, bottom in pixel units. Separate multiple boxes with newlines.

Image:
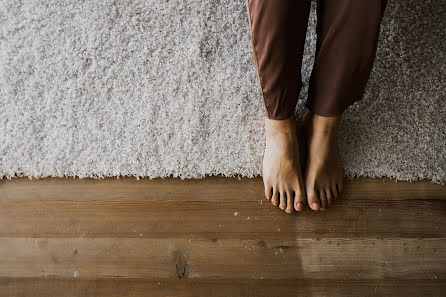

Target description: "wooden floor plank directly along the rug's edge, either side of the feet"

left=0, top=176, right=446, bottom=202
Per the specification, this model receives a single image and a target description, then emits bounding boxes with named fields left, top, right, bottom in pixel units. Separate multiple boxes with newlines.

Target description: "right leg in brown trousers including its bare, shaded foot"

left=302, top=0, right=387, bottom=210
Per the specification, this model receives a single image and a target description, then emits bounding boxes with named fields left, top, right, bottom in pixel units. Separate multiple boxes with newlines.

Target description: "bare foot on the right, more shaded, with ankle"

left=302, top=111, right=344, bottom=210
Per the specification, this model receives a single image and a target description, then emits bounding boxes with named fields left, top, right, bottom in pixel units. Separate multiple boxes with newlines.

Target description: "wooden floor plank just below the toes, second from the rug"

left=0, top=199, right=446, bottom=239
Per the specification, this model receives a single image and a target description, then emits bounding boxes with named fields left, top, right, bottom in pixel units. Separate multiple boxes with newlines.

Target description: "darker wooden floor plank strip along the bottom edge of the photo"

left=0, top=278, right=446, bottom=297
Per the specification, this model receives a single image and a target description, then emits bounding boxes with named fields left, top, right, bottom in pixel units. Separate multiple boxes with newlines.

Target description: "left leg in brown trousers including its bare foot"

left=246, top=0, right=311, bottom=213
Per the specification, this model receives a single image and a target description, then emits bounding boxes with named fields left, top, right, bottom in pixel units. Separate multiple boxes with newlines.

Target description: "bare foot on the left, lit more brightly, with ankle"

left=263, top=115, right=305, bottom=213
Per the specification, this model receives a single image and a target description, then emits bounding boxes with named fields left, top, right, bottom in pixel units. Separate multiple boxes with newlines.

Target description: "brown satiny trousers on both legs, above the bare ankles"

left=246, top=0, right=387, bottom=120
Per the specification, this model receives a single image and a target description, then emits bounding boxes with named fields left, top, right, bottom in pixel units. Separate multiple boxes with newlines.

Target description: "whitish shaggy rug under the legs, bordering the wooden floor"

left=0, top=0, right=446, bottom=183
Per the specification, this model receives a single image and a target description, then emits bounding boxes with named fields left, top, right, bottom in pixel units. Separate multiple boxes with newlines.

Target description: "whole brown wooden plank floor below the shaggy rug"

left=0, top=177, right=446, bottom=297
